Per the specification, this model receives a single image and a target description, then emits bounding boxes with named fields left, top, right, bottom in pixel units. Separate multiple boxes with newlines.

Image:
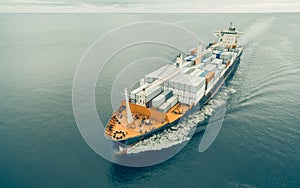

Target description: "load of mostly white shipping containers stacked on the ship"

left=131, top=43, right=236, bottom=112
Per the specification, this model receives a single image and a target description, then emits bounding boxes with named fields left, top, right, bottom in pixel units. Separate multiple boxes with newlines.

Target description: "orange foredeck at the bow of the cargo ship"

left=106, top=101, right=190, bottom=141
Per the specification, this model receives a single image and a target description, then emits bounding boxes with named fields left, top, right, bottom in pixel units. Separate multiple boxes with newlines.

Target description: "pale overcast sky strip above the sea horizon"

left=0, top=0, right=300, bottom=13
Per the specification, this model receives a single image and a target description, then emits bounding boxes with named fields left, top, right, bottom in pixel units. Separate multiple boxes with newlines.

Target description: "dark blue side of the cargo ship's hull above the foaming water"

left=115, top=52, right=242, bottom=145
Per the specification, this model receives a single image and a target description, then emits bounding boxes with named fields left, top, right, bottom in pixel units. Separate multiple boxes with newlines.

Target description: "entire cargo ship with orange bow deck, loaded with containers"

left=105, top=22, right=243, bottom=145
